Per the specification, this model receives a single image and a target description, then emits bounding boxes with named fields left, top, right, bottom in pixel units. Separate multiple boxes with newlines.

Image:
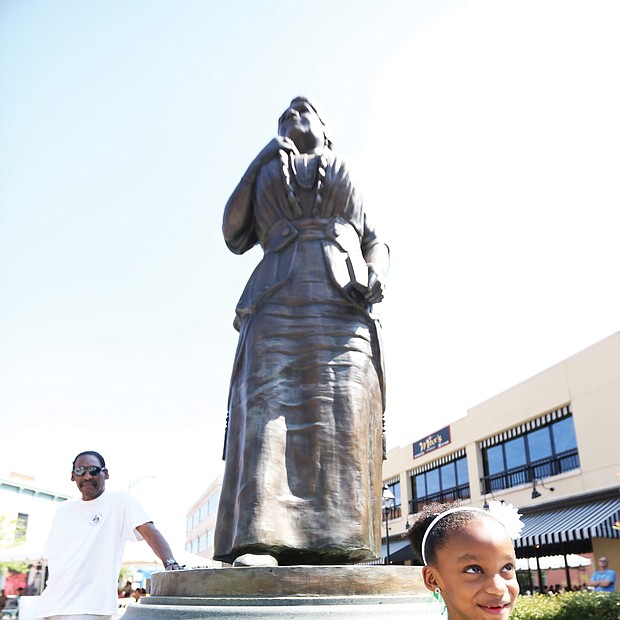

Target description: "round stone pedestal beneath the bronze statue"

left=124, top=566, right=441, bottom=620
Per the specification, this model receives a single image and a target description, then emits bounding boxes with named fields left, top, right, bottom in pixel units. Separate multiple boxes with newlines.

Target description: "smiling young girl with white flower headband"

left=407, top=501, right=523, bottom=620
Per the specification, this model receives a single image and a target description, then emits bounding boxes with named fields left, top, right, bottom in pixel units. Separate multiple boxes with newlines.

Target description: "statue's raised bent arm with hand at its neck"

left=222, top=136, right=298, bottom=254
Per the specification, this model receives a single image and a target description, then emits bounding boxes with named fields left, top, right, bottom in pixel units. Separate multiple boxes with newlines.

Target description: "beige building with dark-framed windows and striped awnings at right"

left=383, top=332, right=620, bottom=585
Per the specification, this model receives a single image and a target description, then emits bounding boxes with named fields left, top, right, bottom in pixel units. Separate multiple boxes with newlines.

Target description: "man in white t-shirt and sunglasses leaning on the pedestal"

left=36, top=451, right=181, bottom=620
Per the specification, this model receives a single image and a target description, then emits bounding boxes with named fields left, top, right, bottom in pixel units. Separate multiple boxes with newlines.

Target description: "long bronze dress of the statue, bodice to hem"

left=214, top=150, right=384, bottom=565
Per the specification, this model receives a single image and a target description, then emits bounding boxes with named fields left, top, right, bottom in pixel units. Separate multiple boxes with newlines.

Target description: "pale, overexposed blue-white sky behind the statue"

left=0, top=0, right=620, bottom=546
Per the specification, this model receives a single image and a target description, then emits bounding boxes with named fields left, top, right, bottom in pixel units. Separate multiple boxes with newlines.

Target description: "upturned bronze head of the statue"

left=278, top=97, right=332, bottom=153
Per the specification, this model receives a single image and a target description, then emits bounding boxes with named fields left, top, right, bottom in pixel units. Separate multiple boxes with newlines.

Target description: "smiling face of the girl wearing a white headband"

left=423, top=517, right=519, bottom=620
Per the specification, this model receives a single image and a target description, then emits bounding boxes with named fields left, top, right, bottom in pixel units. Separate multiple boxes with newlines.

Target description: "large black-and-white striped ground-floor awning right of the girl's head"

left=515, top=499, right=620, bottom=548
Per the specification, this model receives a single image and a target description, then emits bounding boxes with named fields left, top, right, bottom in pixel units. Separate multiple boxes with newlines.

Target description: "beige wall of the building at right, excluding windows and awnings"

left=383, top=332, right=620, bottom=570
